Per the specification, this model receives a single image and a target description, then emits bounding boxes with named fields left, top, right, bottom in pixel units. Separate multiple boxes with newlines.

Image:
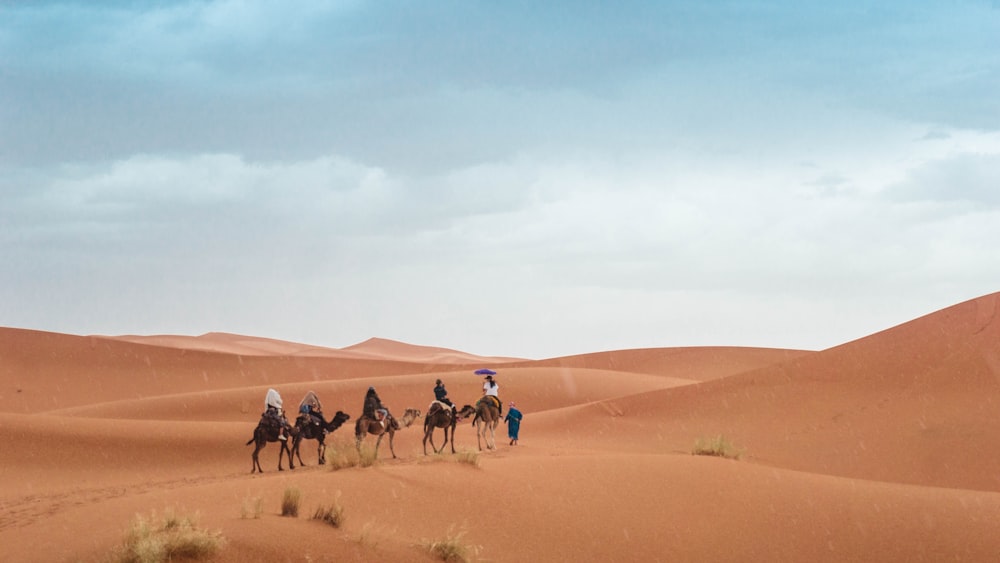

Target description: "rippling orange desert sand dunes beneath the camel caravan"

left=0, top=294, right=1000, bottom=562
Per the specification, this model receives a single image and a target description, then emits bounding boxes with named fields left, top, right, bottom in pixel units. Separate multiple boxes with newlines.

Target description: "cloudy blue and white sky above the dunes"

left=0, top=0, right=1000, bottom=358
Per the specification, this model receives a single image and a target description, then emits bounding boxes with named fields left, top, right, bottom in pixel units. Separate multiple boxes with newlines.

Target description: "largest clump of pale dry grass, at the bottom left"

left=114, top=511, right=226, bottom=563
